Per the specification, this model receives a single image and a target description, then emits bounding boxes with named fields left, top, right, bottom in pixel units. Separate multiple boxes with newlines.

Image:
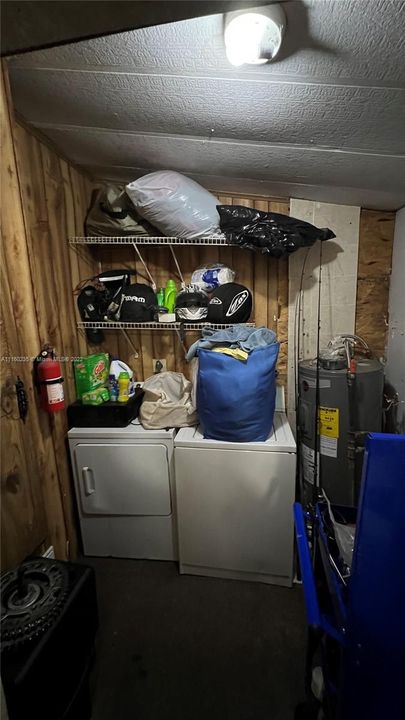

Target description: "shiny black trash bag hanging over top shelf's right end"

left=217, top=205, right=336, bottom=258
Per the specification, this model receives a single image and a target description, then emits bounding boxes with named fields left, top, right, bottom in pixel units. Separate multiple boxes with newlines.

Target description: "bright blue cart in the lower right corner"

left=294, top=433, right=405, bottom=720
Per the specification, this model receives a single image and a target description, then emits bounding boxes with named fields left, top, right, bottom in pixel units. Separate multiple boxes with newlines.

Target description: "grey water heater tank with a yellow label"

left=298, top=357, right=384, bottom=505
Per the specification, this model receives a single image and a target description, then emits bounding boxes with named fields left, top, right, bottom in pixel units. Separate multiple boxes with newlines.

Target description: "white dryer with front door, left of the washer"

left=68, top=424, right=177, bottom=560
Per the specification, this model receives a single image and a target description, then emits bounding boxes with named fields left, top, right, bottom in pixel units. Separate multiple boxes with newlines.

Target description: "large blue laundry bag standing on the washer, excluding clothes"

left=197, top=342, right=279, bottom=442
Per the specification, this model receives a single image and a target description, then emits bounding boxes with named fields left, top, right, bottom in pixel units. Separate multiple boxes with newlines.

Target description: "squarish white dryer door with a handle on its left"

left=74, top=443, right=171, bottom=515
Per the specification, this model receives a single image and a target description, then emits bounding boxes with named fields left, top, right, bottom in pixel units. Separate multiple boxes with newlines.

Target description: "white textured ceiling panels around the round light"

left=10, top=0, right=405, bottom=209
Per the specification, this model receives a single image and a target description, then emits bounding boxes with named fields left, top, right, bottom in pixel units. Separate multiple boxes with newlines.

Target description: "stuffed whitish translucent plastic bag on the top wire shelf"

left=126, top=170, right=221, bottom=240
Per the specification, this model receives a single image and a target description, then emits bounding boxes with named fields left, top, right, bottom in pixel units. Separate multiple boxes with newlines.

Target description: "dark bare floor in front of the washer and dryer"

left=86, top=558, right=305, bottom=720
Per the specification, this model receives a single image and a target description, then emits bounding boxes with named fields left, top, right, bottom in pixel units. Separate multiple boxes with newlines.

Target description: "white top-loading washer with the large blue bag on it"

left=175, top=411, right=296, bottom=586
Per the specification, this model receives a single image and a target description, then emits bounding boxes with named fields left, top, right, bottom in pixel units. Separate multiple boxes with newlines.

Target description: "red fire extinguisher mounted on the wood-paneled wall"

left=35, top=345, right=65, bottom=412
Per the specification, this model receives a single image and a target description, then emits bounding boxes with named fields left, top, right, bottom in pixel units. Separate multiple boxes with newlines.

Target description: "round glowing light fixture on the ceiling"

left=224, top=4, right=287, bottom=67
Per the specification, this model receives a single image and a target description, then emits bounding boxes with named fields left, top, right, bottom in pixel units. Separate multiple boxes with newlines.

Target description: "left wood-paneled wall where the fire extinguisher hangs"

left=0, top=67, right=91, bottom=567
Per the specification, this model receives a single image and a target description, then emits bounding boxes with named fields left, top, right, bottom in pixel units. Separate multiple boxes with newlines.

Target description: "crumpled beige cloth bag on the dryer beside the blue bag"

left=139, top=372, right=198, bottom=430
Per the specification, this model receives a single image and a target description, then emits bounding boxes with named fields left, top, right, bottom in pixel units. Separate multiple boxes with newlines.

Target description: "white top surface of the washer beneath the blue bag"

left=174, top=411, right=296, bottom=452
